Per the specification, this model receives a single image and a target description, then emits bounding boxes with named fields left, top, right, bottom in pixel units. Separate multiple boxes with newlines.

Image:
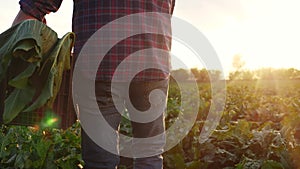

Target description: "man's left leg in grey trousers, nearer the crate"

left=79, top=81, right=121, bottom=169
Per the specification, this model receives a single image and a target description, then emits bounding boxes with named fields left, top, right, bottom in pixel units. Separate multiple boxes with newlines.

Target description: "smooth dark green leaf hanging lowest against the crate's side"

left=3, top=88, right=35, bottom=123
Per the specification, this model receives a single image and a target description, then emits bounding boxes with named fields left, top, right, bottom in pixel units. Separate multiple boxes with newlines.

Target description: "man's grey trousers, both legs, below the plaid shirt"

left=79, top=80, right=168, bottom=169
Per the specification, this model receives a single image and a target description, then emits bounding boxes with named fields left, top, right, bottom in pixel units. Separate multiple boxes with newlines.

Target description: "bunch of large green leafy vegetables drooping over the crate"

left=0, top=20, right=75, bottom=123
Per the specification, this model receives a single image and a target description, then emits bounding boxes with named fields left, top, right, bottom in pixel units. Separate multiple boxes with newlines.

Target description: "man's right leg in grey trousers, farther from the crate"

left=129, top=80, right=168, bottom=169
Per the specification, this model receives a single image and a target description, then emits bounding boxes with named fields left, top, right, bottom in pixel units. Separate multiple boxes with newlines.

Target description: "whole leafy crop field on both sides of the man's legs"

left=0, top=80, right=300, bottom=169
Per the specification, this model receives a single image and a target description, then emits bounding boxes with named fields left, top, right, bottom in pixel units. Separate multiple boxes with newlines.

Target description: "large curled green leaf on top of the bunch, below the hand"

left=0, top=20, right=57, bottom=81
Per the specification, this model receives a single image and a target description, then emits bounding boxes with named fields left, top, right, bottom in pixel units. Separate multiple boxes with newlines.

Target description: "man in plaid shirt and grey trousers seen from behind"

left=13, top=0, right=175, bottom=169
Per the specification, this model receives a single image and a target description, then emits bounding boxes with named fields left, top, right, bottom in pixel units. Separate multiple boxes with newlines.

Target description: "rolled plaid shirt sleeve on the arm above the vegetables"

left=19, top=0, right=63, bottom=21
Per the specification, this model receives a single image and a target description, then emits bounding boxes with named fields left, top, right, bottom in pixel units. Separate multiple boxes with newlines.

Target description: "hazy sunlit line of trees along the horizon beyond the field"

left=171, top=68, right=300, bottom=82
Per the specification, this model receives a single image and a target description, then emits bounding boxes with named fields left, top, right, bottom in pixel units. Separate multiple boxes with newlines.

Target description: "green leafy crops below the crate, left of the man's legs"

left=0, top=123, right=83, bottom=169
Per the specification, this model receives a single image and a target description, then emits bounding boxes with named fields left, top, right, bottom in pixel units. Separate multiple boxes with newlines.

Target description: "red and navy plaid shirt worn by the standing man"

left=20, top=0, right=175, bottom=81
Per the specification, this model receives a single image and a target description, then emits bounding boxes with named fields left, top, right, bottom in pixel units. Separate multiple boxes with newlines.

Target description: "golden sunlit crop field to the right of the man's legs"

left=165, top=80, right=300, bottom=169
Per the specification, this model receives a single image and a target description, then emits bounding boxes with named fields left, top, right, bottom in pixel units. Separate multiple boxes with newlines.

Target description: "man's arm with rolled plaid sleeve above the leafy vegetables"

left=13, top=0, right=63, bottom=25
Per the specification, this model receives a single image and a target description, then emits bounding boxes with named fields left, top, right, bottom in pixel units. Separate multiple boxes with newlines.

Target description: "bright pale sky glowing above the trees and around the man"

left=0, top=0, right=300, bottom=73
